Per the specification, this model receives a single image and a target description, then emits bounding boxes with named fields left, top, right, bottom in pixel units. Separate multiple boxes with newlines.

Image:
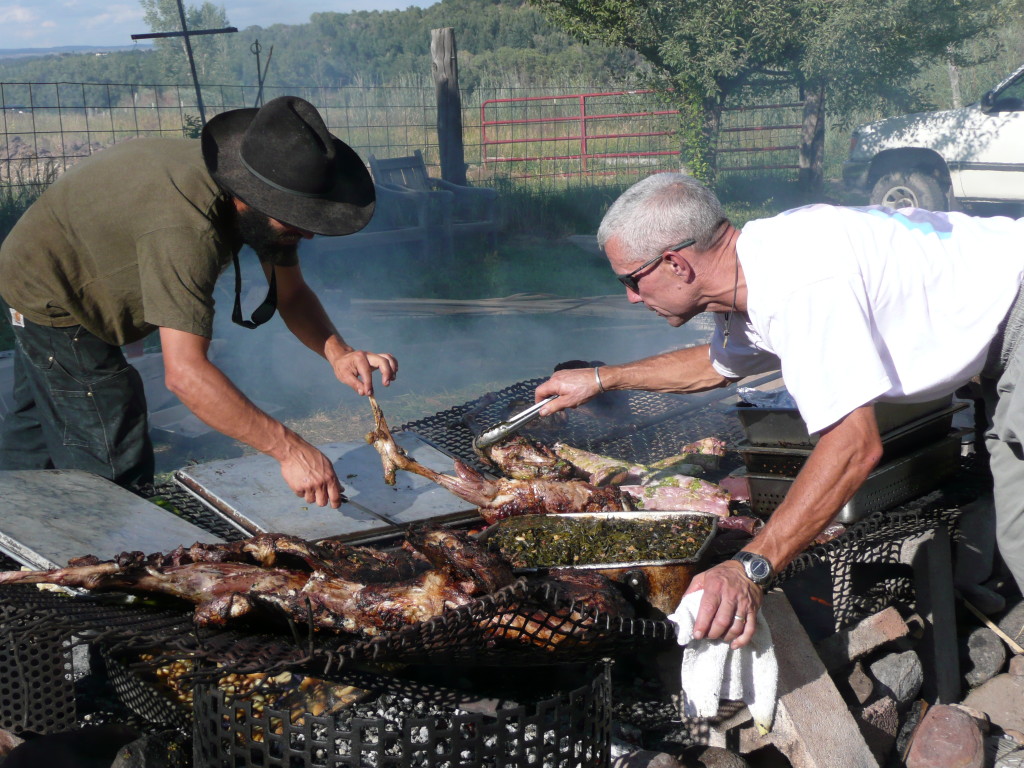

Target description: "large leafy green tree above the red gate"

left=530, top=0, right=998, bottom=191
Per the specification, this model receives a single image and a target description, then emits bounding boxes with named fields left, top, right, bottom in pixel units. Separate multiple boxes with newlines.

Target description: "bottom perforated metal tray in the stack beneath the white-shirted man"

left=745, top=429, right=964, bottom=523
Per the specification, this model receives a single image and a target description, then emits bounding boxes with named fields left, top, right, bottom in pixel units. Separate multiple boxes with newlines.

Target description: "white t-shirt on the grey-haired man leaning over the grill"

left=711, top=205, right=1024, bottom=432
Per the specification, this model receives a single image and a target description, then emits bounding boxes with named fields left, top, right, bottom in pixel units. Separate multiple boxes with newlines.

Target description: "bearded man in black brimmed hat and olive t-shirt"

left=0, top=96, right=398, bottom=507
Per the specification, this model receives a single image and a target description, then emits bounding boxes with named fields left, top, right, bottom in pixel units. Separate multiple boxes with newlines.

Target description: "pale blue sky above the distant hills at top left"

left=0, top=0, right=436, bottom=49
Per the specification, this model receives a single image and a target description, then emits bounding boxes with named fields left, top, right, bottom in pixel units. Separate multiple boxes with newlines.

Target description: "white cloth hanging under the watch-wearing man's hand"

left=669, top=590, right=778, bottom=734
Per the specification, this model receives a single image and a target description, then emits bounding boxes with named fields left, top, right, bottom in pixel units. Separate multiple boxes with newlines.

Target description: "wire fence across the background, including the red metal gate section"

left=0, top=83, right=801, bottom=187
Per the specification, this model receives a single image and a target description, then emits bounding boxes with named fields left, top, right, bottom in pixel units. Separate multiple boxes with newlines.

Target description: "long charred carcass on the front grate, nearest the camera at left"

left=0, top=529, right=513, bottom=636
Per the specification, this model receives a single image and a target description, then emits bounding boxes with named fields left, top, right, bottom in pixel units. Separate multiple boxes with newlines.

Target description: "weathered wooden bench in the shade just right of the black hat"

left=370, top=150, right=499, bottom=250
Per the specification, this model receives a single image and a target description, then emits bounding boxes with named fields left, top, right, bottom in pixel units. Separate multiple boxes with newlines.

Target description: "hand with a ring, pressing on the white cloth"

left=686, top=560, right=764, bottom=650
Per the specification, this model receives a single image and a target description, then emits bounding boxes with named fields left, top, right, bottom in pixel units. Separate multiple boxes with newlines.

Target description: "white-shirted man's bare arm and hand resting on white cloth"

left=686, top=404, right=882, bottom=648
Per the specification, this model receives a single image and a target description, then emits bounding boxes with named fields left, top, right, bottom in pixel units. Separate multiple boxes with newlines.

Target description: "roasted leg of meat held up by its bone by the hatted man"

left=367, top=397, right=623, bottom=523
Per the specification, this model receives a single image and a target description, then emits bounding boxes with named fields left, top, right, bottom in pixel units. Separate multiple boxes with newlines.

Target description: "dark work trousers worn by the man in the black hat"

left=0, top=301, right=154, bottom=489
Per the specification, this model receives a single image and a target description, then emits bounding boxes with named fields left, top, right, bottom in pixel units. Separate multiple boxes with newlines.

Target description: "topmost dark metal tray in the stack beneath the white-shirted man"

left=729, top=395, right=952, bottom=447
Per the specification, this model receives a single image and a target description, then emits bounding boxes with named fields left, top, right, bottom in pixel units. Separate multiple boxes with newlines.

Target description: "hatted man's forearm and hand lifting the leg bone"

left=264, top=265, right=398, bottom=395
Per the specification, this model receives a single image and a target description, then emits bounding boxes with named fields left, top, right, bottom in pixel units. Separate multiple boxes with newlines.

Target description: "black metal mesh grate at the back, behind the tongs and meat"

left=401, top=379, right=742, bottom=471
